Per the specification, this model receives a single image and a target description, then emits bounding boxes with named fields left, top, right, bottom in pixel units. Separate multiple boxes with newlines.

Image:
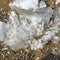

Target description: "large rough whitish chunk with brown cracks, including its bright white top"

left=0, top=0, right=60, bottom=51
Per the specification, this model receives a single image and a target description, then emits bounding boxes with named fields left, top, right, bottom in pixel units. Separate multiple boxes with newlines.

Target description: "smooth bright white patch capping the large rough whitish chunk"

left=10, top=0, right=38, bottom=10
